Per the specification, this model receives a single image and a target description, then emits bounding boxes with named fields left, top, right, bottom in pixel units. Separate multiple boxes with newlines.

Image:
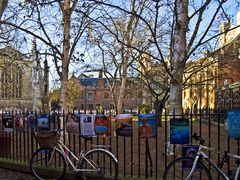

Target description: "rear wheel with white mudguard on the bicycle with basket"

left=79, top=149, right=118, bottom=179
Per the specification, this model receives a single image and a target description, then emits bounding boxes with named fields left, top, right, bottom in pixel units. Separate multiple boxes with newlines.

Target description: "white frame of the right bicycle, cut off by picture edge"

left=186, top=145, right=240, bottom=180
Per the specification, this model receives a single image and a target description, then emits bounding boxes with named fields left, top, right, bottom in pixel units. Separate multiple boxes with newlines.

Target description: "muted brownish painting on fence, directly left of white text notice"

left=66, top=113, right=80, bottom=134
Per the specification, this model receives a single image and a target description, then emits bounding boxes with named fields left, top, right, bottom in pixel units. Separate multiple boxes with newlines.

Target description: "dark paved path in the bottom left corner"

left=0, top=168, right=35, bottom=180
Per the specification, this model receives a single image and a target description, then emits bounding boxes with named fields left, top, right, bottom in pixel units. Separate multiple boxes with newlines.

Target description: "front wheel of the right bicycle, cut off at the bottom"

left=163, top=157, right=212, bottom=180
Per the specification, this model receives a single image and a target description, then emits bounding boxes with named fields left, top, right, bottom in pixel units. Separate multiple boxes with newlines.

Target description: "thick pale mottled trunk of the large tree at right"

left=170, top=0, right=188, bottom=115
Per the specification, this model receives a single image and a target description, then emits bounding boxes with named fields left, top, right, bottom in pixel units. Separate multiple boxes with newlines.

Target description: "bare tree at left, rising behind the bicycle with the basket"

left=0, top=0, right=91, bottom=110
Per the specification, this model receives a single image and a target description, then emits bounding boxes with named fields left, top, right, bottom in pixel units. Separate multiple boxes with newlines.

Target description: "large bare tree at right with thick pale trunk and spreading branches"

left=86, top=0, right=236, bottom=114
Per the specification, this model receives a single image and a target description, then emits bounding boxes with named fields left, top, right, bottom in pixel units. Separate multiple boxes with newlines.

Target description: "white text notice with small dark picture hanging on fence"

left=80, top=114, right=95, bottom=137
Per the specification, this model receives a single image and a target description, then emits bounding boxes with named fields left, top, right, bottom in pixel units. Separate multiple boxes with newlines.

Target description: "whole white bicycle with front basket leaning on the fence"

left=30, top=130, right=118, bottom=180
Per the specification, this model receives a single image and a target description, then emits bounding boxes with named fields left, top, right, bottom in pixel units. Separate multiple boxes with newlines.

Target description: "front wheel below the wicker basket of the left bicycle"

left=30, top=148, right=66, bottom=180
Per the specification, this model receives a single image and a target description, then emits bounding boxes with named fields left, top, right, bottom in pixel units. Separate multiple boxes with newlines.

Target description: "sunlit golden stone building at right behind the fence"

left=183, top=12, right=240, bottom=109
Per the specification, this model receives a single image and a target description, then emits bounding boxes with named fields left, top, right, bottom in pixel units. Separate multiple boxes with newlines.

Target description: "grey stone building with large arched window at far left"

left=0, top=47, right=46, bottom=110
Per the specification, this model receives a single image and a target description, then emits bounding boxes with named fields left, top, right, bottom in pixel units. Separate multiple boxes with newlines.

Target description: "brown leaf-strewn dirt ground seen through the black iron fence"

left=0, top=118, right=239, bottom=179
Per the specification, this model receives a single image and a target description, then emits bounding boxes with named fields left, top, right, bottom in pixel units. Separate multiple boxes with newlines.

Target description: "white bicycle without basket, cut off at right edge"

left=163, top=133, right=240, bottom=180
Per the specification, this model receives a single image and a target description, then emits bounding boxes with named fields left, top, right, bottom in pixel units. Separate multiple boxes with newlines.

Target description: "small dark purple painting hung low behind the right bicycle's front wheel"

left=182, top=145, right=200, bottom=171
